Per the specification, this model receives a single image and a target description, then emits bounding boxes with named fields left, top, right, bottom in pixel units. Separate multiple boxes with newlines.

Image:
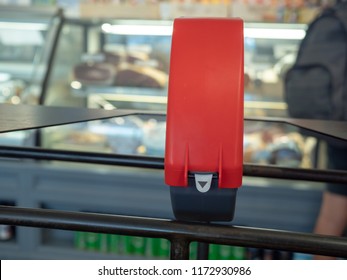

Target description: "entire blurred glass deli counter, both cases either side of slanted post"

left=0, top=10, right=317, bottom=172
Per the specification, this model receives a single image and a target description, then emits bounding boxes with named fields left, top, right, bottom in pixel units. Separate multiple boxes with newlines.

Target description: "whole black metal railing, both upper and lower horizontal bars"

left=0, top=146, right=347, bottom=259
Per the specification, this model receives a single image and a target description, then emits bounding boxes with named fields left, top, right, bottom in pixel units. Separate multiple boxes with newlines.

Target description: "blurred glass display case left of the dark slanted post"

left=0, top=6, right=61, bottom=146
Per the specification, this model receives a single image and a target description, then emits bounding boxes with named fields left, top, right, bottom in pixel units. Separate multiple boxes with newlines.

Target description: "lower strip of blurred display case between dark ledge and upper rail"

left=42, top=115, right=317, bottom=168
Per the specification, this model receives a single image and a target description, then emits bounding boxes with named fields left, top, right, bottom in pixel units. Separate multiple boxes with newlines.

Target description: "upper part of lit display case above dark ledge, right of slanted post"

left=46, top=20, right=306, bottom=116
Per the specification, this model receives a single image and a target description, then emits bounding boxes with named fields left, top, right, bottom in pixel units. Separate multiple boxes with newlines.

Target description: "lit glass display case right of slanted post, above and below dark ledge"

left=42, top=20, right=315, bottom=167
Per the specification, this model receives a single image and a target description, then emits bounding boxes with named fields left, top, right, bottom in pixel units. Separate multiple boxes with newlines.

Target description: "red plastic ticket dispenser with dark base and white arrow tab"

left=165, top=18, right=244, bottom=221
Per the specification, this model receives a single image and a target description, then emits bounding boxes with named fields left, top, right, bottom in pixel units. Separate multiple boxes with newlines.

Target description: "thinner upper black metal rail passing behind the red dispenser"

left=0, top=146, right=347, bottom=184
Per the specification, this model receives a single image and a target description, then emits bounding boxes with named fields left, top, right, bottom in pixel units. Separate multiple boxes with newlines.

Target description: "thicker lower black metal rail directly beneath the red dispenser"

left=0, top=206, right=347, bottom=258
